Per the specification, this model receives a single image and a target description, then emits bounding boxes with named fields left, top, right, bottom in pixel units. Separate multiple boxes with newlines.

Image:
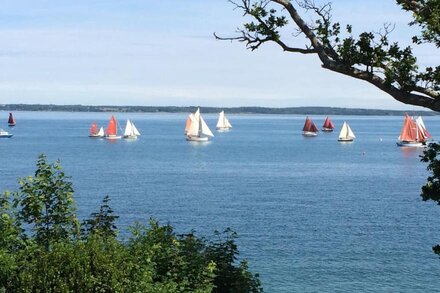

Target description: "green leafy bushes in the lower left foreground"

left=0, top=155, right=262, bottom=293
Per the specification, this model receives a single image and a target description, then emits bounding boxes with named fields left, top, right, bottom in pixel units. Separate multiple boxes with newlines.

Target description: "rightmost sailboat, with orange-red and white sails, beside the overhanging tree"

left=396, top=114, right=424, bottom=147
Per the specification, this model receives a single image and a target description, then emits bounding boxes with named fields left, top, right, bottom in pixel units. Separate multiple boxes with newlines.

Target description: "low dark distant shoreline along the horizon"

left=0, top=104, right=434, bottom=116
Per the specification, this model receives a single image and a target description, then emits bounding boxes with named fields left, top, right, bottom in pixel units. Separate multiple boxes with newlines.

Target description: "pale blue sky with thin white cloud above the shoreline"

left=0, top=0, right=440, bottom=109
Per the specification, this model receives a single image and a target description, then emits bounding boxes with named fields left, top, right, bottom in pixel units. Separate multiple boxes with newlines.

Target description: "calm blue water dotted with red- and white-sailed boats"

left=0, top=112, right=440, bottom=292
